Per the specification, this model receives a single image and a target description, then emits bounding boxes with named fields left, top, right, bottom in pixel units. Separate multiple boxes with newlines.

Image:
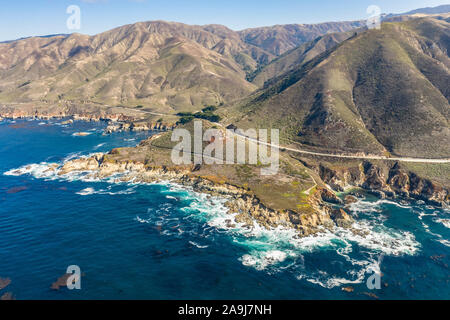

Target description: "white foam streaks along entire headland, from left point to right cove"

left=5, top=159, right=426, bottom=287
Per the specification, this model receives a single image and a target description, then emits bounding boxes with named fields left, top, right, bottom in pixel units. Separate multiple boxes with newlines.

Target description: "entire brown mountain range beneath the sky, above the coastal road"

left=0, top=14, right=450, bottom=157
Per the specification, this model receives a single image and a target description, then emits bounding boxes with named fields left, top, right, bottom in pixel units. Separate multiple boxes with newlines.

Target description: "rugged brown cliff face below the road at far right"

left=317, top=161, right=450, bottom=206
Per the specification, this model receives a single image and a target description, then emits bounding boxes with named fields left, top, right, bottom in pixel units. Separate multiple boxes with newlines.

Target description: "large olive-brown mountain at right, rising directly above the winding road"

left=227, top=17, right=450, bottom=157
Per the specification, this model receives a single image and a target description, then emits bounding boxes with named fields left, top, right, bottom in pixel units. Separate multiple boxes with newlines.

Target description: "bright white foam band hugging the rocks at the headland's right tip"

left=185, top=191, right=420, bottom=269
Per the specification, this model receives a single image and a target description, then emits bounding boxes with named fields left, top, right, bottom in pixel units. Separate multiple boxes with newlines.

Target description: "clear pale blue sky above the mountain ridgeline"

left=0, top=0, right=450, bottom=41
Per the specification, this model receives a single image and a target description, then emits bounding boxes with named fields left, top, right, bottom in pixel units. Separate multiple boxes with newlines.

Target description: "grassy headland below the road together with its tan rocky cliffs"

left=2, top=113, right=449, bottom=236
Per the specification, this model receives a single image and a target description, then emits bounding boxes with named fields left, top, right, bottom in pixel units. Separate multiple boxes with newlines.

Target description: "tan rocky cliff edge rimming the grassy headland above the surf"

left=2, top=117, right=446, bottom=236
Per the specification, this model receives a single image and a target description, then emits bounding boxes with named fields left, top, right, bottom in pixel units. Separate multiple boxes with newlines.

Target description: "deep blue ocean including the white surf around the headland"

left=0, top=121, right=450, bottom=299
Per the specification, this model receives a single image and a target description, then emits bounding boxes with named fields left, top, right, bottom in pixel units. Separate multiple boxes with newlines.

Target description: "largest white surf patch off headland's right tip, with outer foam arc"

left=174, top=188, right=421, bottom=288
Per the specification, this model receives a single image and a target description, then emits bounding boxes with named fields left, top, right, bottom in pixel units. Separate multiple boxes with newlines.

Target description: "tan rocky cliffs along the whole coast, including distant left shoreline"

left=0, top=108, right=449, bottom=236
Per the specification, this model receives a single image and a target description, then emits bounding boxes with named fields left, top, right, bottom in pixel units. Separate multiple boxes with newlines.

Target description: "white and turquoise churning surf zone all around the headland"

left=4, top=160, right=442, bottom=288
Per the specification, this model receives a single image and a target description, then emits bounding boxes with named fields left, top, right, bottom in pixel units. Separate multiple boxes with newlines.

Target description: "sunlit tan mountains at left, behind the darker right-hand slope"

left=0, top=21, right=370, bottom=113
